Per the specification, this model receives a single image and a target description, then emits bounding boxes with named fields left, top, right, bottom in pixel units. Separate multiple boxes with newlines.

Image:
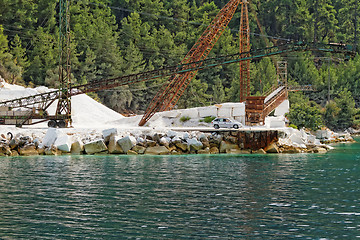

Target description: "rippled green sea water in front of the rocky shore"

left=0, top=140, right=360, bottom=240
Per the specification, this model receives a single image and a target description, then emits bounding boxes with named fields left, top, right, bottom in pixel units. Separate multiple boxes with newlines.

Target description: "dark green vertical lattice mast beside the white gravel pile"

left=56, top=0, right=71, bottom=127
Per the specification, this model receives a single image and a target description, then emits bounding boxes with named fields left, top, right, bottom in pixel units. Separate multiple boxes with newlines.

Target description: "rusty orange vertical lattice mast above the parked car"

left=240, top=0, right=250, bottom=102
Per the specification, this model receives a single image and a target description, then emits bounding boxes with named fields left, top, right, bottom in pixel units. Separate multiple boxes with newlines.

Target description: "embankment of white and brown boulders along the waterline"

left=0, top=128, right=352, bottom=156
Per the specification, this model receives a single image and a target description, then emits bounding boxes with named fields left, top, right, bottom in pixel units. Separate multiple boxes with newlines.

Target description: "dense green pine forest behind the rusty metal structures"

left=0, top=0, right=360, bottom=128
